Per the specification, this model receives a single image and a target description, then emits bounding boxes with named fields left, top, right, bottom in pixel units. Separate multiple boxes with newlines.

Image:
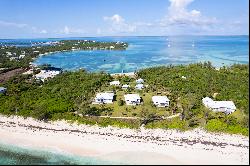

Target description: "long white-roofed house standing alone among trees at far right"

left=202, top=97, right=236, bottom=114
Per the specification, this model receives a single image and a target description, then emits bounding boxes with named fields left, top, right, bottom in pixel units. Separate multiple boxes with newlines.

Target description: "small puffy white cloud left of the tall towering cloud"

left=103, top=14, right=137, bottom=33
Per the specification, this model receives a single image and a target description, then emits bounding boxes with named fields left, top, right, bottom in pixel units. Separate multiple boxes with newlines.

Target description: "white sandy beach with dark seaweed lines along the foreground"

left=0, top=115, right=249, bottom=165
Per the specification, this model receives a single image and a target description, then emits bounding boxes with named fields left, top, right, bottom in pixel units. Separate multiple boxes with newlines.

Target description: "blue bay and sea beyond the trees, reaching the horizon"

left=0, top=36, right=249, bottom=73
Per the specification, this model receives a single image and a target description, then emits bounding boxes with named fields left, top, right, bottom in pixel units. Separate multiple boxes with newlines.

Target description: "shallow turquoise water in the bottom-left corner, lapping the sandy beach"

left=0, top=142, right=125, bottom=165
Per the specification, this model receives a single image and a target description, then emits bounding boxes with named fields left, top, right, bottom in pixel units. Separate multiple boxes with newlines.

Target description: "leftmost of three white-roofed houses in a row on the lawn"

left=93, top=92, right=115, bottom=104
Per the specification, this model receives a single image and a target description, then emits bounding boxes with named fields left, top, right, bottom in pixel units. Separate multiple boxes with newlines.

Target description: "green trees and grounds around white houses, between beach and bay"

left=0, top=62, right=249, bottom=135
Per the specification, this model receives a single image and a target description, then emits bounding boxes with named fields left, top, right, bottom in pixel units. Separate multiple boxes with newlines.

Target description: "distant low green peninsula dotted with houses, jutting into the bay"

left=0, top=40, right=128, bottom=72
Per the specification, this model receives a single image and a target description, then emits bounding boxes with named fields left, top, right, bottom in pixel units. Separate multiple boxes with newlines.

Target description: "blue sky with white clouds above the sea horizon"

left=0, top=0, right=249, bottom=39
